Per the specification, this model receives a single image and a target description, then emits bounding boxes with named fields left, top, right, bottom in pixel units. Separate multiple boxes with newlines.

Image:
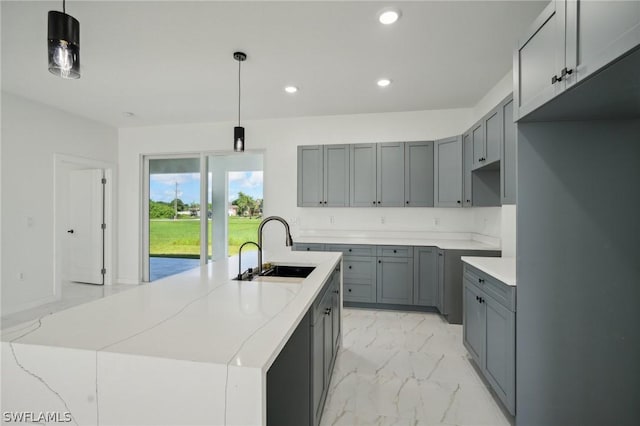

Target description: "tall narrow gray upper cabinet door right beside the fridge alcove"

left=500, top=97, right=517, bottom=204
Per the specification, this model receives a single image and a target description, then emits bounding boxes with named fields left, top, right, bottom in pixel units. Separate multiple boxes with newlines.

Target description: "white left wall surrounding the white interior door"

left=1, top=92, right=118, bottom=315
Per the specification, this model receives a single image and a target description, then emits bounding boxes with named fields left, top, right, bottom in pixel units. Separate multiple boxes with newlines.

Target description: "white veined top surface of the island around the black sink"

left=2, top=252, right=341, bottom=371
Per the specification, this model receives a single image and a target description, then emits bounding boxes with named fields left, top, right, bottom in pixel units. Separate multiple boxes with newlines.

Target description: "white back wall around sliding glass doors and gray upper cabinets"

left=118, top=109, right=482, bottom=282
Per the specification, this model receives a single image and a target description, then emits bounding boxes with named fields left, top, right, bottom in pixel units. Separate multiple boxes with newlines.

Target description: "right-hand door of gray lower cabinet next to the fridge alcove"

left=484, top=296, right=516, bottom=414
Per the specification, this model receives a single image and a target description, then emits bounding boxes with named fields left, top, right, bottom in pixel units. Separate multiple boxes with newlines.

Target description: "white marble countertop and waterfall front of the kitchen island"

left=2, top=252, right=342, bottom=425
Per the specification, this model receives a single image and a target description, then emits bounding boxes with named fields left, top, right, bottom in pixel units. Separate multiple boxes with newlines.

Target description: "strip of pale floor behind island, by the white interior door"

left=0, top=282, right=136, bottom=330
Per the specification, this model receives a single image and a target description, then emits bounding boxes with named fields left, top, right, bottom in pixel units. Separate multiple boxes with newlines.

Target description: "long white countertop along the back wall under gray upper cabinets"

left=294, top=235, right=500, bottom=250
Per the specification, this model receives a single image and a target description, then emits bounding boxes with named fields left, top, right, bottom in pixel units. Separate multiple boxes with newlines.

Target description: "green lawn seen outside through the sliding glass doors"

left=149, top=216, right=260, bottom=257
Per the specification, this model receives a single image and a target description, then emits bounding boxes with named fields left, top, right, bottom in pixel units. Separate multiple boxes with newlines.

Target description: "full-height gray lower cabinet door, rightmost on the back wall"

left=413, top=247, right=438, bottom=306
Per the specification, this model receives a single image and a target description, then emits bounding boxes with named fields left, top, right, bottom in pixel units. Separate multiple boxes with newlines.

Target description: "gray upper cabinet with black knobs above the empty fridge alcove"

left=513, top=0, right=640, bottom=120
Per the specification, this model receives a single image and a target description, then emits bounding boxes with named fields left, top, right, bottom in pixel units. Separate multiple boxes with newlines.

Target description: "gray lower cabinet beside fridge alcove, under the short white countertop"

left=463, top=265, right=516, bottom=415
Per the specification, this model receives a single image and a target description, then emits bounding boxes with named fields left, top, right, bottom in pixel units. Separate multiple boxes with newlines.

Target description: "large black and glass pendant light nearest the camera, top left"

left=47, top=0, right=80, bottom=78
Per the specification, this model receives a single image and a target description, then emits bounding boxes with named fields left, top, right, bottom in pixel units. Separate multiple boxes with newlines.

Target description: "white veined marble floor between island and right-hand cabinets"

left=321, top=308, right=513, bottom=426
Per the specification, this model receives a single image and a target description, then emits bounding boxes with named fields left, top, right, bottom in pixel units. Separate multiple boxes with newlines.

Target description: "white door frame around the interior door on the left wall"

left=53, top=153, right=118, bottom=299
